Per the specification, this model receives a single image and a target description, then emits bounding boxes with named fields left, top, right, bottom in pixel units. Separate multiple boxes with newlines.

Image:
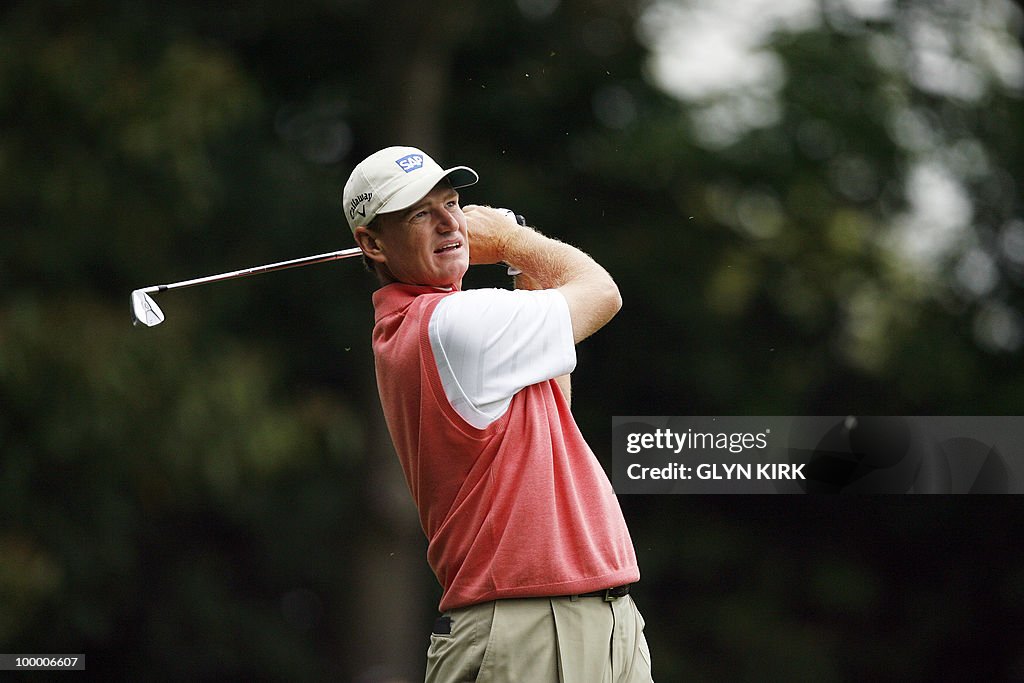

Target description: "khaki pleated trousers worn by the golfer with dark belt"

left=426, top=595, right=652, bottom=683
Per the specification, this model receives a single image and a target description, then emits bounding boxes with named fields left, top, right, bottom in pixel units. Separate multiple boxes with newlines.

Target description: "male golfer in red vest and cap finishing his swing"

left=344, top=146, right=651, bottom=683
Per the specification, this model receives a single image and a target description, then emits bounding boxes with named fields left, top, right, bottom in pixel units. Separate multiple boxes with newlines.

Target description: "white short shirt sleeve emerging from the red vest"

left=428, top=289, right=577, bottom=429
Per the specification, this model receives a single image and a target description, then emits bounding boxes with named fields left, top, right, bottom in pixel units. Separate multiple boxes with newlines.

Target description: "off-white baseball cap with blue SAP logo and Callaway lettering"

left=342, top=146, right=479, bottom=232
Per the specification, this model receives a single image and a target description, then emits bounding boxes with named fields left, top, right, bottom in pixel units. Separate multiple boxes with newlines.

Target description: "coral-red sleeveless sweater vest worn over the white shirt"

left=373, top=284, right=640, bottom=611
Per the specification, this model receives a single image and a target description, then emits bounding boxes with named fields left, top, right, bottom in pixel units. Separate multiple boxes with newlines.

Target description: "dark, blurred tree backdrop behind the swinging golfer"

left=0, top=0, right=1024, bottom=682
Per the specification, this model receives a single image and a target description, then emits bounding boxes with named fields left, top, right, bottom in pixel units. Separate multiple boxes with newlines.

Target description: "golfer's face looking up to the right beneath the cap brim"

left=371, top=181, right=469, bottom=287
